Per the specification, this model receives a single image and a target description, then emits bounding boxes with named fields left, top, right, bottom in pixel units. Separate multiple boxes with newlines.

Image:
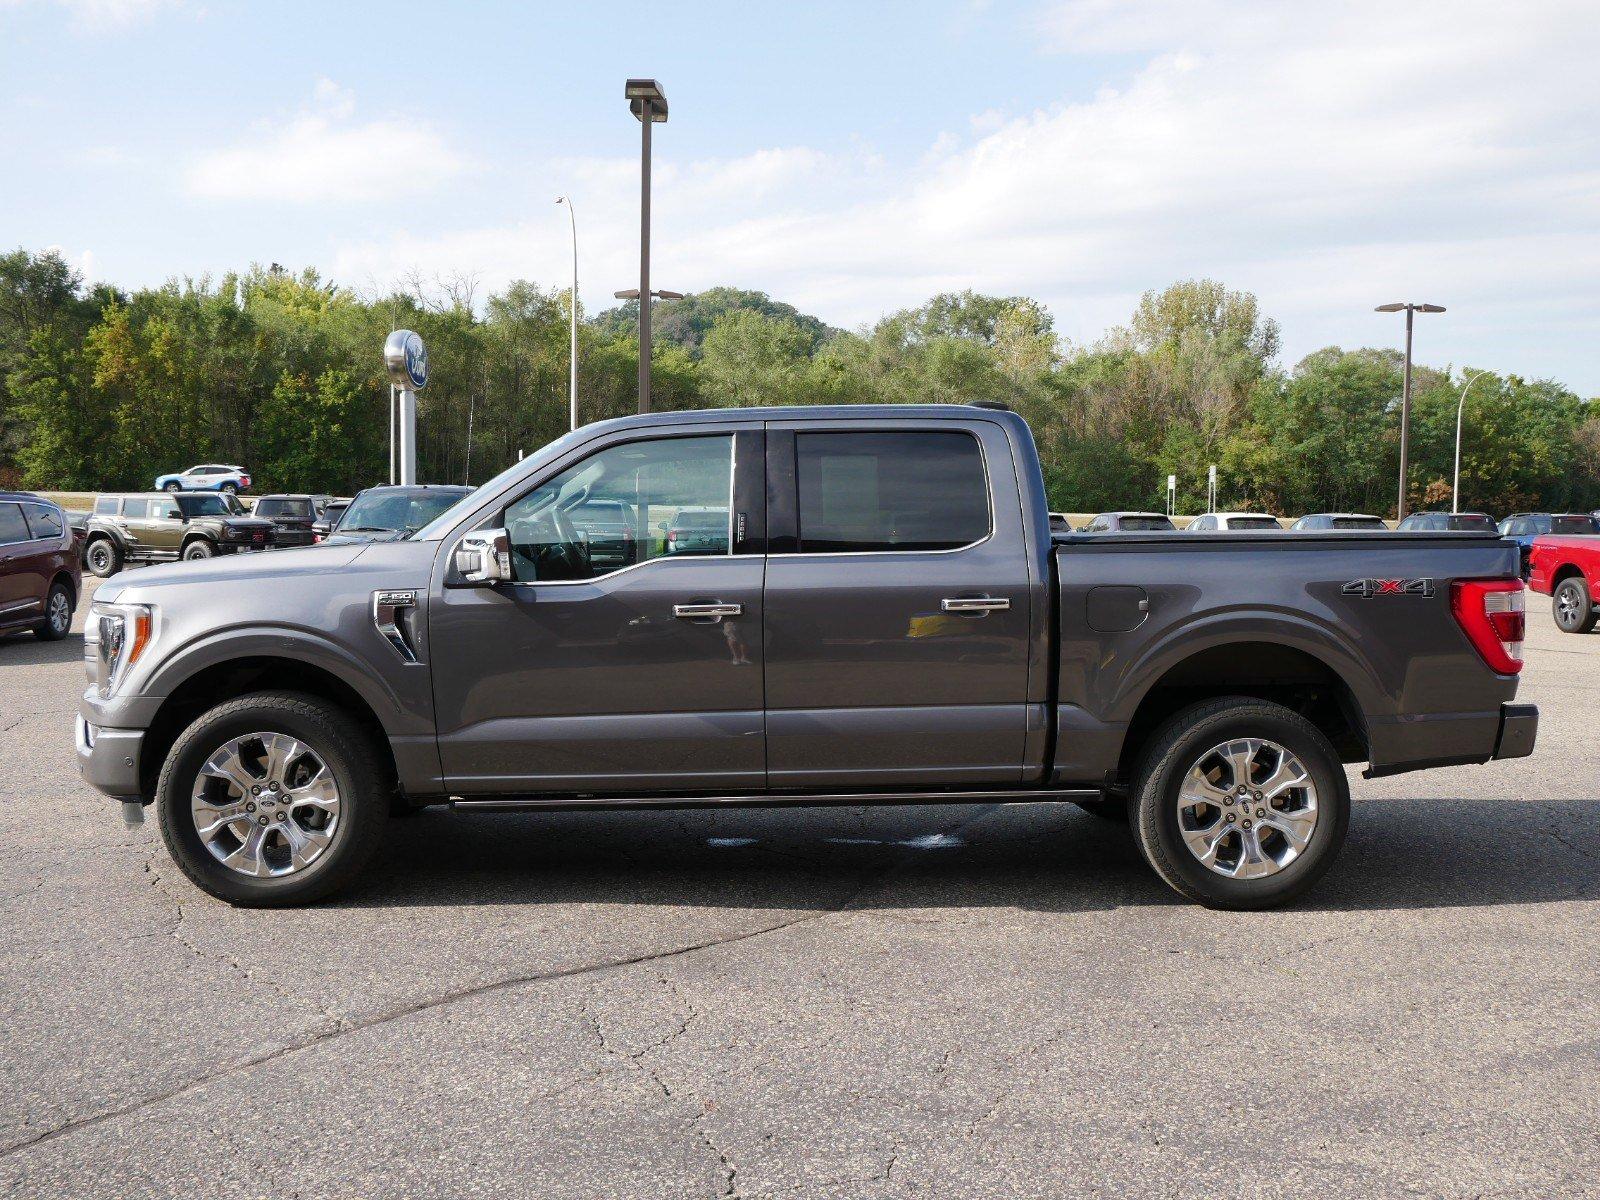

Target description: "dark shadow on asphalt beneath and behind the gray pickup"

left=344, top=798, right=1600, bottom=914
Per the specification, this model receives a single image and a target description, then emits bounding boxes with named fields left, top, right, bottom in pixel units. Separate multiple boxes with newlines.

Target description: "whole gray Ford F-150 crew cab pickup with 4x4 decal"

left=77, top=406, right=1538, bottom=909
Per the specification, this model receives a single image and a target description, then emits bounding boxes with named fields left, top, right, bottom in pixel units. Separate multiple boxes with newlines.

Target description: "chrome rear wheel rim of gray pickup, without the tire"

left=1178, top=738, right=1317, bottom=878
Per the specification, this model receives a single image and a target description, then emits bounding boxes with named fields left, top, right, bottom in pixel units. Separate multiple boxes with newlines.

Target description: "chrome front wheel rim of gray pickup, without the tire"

left=190, top=733, right=339, bottom=877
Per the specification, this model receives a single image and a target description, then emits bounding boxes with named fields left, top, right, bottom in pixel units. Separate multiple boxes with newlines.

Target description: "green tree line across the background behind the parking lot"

left=0, top=250, right=1600, bottom=515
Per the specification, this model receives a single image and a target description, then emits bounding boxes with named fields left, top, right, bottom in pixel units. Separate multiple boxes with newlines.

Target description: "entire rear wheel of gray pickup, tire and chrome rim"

left=1131, top=696, right=1350, bottom=909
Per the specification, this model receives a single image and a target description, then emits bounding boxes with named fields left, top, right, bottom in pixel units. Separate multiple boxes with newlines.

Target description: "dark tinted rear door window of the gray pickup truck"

left=795, top=430, right=990, bottom=554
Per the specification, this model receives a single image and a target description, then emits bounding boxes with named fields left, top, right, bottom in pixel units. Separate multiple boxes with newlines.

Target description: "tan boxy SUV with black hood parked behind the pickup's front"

left=83, top=491, right=277, bottom=579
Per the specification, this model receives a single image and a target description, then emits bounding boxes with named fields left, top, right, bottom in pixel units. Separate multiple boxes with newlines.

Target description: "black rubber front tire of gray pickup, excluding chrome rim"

left=155, top=691, right=394, bottom=907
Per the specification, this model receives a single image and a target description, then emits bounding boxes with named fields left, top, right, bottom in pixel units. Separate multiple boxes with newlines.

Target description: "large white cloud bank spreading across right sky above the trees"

left=328, top=0, right=1600, bottom=382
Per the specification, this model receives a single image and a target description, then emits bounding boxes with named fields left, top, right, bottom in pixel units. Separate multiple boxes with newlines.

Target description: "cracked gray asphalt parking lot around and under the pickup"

left=0, top=579, right=1600, bottom=1198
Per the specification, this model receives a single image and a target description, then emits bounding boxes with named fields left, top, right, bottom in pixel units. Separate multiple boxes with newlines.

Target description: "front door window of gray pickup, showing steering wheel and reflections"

left=502, top=434, right=733, bottom=582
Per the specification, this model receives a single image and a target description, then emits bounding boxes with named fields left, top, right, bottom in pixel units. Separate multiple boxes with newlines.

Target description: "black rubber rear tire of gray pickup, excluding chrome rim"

left=1131, top=696, right=1350, bottom=910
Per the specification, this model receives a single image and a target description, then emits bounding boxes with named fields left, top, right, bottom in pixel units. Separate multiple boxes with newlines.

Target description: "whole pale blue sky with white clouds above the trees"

left=0, top=0, right=1600, bottom=397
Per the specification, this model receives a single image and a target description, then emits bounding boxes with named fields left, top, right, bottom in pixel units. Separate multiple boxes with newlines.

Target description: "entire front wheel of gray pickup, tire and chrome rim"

left=155, top=691, right=394, bottom=907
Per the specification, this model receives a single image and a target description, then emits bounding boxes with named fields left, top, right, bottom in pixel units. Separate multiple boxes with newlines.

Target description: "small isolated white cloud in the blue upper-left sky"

left=184, top=78, right=467, bottom=205
